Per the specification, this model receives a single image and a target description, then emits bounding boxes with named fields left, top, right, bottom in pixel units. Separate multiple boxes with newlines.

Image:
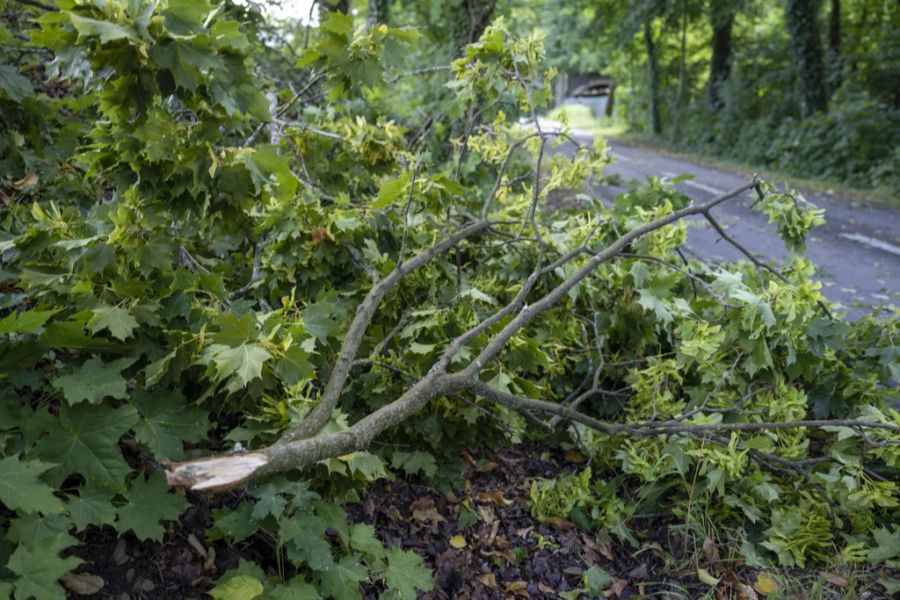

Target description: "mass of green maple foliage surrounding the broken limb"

left=0, top=0, right=900, bottom=600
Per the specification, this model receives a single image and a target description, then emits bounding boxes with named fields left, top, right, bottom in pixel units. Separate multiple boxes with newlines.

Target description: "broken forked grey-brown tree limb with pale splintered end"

left=167, top=178, right=884, bottom=490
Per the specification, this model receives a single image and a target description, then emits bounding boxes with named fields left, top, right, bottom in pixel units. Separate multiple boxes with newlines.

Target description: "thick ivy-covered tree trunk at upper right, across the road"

left=785, top=0, right=828, bottom=115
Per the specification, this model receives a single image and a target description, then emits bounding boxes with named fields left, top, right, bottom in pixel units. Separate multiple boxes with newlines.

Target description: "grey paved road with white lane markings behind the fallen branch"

left=560, top=127, right=900, bottom=318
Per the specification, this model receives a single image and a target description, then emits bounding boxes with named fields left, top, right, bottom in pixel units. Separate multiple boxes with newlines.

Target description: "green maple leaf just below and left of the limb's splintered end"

left=117, top=474, right=189, bottom=542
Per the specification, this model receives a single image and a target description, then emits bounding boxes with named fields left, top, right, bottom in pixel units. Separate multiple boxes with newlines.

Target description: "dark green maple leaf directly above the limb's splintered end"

left=131, top=390, right=209, bottom=459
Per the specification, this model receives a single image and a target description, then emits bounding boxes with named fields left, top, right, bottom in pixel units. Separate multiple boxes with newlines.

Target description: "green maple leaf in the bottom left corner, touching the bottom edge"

left=6, top=535, right=81, bottom=600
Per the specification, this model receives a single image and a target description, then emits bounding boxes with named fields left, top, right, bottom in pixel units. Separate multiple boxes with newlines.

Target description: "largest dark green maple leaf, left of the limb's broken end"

left=36, top=404, right=138, bottom=491
